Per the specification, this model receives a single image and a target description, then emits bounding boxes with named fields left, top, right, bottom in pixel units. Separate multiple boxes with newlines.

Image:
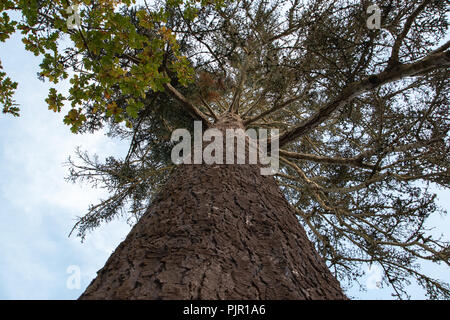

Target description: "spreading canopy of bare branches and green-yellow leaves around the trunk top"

left=0, top=0, right=450, bottom=298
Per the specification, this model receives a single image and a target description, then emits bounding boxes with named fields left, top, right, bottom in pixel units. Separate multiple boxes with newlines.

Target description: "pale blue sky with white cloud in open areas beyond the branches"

left=0, top=15, right=450, bottom=300
